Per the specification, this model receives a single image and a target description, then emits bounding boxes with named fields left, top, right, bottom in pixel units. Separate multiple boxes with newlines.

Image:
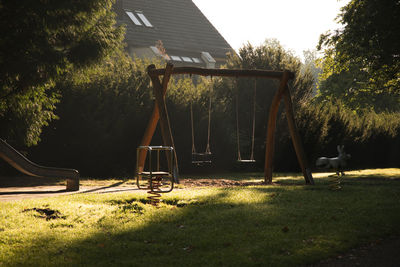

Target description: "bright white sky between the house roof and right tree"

left=193, top=0, right=349, bottom=58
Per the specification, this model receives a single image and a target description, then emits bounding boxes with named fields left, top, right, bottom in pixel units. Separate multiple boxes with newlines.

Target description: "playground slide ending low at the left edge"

left=0, top=139, right=79, bottom=191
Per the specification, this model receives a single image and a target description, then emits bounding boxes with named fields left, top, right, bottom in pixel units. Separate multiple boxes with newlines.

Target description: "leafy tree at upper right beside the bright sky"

left=318, top=0, right=400, bottom=111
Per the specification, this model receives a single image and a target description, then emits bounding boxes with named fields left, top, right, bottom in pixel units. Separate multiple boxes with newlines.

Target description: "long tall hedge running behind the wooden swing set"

left=23, top=38, right=400, bottom=177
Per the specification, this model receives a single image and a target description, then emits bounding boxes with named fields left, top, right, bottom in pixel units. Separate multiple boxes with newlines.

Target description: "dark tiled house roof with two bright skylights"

left=116, top=0, right=233, bottom=62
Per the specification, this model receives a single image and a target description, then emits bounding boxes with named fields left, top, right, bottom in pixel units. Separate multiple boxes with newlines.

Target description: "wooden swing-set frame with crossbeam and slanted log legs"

left=137, top=63, right=314, bottom=184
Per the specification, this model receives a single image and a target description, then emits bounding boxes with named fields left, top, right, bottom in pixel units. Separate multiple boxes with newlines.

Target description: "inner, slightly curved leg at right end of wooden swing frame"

left=264, top=71, right=290, bottom=183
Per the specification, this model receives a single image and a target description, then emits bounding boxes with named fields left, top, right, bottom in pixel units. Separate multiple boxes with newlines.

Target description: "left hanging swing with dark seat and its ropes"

left=190, top=77, right=212, bottom=166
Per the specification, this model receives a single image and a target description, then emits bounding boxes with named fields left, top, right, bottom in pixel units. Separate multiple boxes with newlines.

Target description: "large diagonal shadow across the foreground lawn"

left=5, top=178, right=400, bottom=266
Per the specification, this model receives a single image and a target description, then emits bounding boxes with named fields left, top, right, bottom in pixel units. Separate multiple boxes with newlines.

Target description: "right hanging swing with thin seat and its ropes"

left=236, top=79, right=257, bottom=163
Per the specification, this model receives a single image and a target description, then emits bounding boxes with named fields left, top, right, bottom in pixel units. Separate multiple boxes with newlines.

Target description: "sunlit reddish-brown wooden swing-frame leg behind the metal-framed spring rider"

left=136, top=63, right=176, bottom=172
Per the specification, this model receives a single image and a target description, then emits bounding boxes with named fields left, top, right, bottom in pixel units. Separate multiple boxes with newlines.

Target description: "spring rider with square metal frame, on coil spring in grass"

left=136, top=146, right=174, bottom=206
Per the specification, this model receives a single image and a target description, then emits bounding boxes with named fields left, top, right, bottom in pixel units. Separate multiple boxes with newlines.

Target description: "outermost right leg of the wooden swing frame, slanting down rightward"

left=283, top=85, right=314, bottom=184
